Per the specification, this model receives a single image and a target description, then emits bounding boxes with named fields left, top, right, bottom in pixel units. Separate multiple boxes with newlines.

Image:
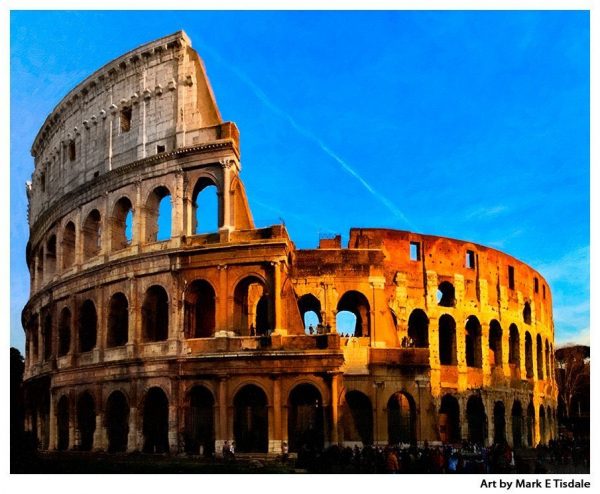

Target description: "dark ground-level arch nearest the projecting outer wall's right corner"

left=288, top=384, right=325, bottom=451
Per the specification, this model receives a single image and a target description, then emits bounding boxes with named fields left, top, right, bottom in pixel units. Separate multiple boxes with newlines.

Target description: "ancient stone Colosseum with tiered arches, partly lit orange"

left=22, top=31, right=557, bottom=455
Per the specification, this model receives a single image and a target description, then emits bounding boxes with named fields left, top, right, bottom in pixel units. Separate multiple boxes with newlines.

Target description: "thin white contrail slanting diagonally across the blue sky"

left=200, top=39, right=413, bottom=227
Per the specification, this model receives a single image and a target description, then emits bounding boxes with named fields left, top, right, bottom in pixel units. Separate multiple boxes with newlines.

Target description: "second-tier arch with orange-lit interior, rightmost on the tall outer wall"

left=233, top=276, right=273, bottom=336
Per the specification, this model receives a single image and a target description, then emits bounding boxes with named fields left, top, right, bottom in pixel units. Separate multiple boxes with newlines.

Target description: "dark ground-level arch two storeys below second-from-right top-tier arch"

left=143, top=387, right=169, bottom=453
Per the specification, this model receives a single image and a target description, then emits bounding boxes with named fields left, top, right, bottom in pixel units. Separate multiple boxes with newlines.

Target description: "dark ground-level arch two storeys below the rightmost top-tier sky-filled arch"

left=185, top=386, right=215, bottom=456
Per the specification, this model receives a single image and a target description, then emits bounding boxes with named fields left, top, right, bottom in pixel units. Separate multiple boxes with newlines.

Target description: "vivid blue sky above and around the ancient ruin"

left=10, top=11, right=590, bottom=350
